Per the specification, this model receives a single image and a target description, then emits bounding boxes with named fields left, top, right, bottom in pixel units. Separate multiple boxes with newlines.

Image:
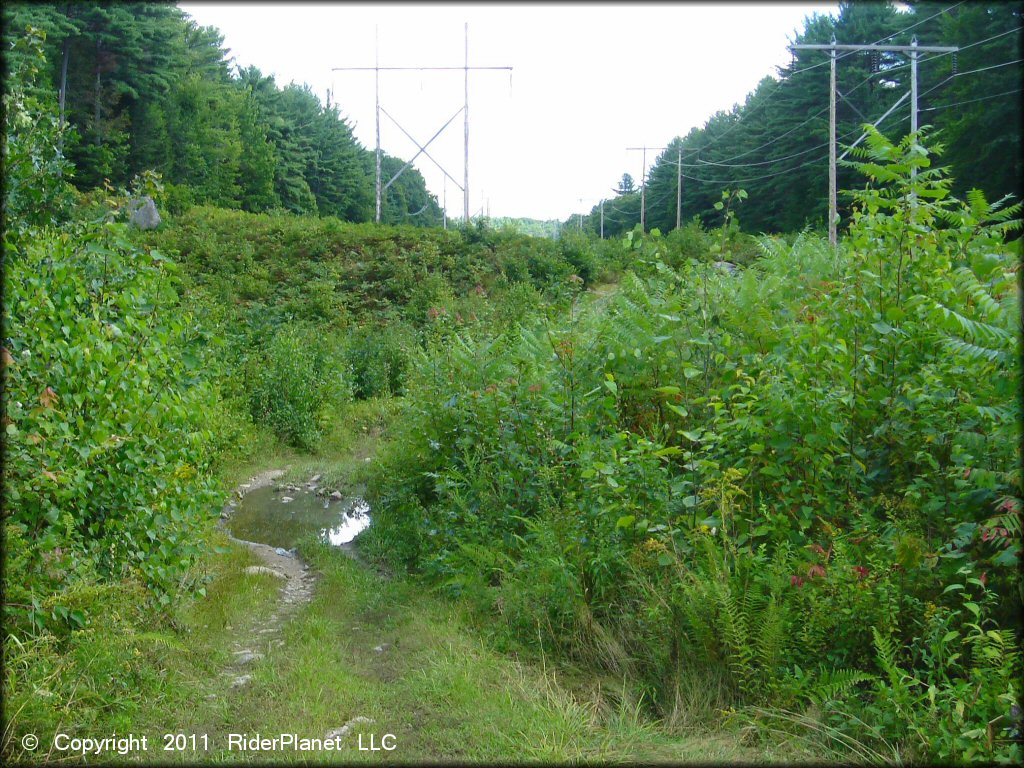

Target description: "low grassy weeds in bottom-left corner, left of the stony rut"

left=0, top=535, right=278, bottom=764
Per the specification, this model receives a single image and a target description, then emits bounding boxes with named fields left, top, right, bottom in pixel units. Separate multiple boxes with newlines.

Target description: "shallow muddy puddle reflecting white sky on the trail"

left=227, top=487, right=370, bottom=549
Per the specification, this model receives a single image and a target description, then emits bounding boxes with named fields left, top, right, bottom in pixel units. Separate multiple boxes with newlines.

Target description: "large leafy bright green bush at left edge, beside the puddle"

left=4, top=218, right=224, bottom=624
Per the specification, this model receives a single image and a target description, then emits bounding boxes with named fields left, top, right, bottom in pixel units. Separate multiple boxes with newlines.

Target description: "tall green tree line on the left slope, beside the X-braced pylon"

left=3, top=2, right=441, bottom=225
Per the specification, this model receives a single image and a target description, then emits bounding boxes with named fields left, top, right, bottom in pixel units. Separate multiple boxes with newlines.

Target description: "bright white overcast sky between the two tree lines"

left=178, top=2, right=838, bottom=220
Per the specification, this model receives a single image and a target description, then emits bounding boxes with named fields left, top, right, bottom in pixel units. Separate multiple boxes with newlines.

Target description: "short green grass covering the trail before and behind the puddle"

left=2, top=400, right=823, bottom=763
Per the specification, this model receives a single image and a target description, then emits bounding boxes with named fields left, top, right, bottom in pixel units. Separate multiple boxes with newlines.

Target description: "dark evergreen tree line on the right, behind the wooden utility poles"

left=589, top=0, right=1024, bottom=237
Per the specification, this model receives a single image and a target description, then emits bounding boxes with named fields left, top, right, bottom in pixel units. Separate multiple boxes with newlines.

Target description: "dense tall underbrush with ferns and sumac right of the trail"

left=368, top=133, right=1022, bottom=761
